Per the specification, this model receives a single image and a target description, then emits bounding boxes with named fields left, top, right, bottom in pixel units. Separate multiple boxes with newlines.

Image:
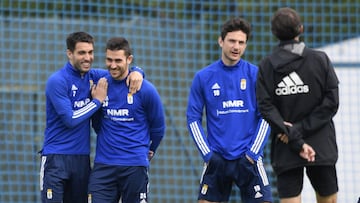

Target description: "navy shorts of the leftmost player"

left=40, top=154, right=90, bottom=203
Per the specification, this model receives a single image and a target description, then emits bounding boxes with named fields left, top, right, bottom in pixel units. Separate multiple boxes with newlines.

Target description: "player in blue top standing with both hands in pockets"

left=187, top=17, right=272, bottom=203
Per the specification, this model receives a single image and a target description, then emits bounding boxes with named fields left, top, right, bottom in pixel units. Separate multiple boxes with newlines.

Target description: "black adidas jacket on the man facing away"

left=256, top=41, right=339, bottom=174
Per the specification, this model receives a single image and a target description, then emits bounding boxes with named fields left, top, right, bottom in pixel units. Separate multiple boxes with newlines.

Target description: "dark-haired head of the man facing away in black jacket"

left=271, top=7, right=302, bottom=41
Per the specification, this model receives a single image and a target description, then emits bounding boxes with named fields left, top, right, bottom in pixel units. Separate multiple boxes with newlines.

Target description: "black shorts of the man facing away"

left=277, top=166, right=339, bottom=198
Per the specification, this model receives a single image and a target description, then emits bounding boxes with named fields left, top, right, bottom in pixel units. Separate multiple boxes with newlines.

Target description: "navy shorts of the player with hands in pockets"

left=198, top=153, right=272, bottom=203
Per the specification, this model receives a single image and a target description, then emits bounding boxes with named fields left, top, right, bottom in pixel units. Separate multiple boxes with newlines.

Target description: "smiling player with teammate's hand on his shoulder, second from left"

left=89, top=37, right=165, bottom=203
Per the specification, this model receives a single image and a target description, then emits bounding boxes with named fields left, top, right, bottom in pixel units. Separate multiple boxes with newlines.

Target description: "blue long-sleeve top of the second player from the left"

left=93, top=75, right=165, bottom=166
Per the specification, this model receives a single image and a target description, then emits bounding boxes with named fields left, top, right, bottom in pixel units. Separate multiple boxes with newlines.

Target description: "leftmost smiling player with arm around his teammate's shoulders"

left=40, top=32, right=143, bottom=203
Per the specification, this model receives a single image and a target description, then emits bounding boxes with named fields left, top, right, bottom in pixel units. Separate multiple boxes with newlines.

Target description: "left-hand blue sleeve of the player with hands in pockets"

left=186, top=74, right=212, bottom=162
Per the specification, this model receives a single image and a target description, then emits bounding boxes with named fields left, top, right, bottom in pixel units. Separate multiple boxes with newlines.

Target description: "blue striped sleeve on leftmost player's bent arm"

left=46, top=74, right=101, bottom=128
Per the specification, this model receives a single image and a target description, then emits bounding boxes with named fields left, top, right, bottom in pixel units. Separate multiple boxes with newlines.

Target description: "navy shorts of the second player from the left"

left=88, top=163, right=149, bottom=203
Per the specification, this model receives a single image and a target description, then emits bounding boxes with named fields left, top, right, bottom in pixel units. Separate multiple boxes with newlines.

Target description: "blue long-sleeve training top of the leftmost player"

left=42, top=62, right=107, bottom=155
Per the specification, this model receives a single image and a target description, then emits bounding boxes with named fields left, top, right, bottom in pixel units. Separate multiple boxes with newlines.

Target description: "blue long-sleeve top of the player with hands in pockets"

left=187, top=60, right=270, bottom=162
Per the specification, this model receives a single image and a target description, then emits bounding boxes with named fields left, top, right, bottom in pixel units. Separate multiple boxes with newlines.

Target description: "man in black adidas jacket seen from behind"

left=256, top=8, right=339, bottom=203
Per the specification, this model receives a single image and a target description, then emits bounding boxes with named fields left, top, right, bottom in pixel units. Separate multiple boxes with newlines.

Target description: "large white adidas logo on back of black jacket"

left=275, top=72, right=310, bottom=96
